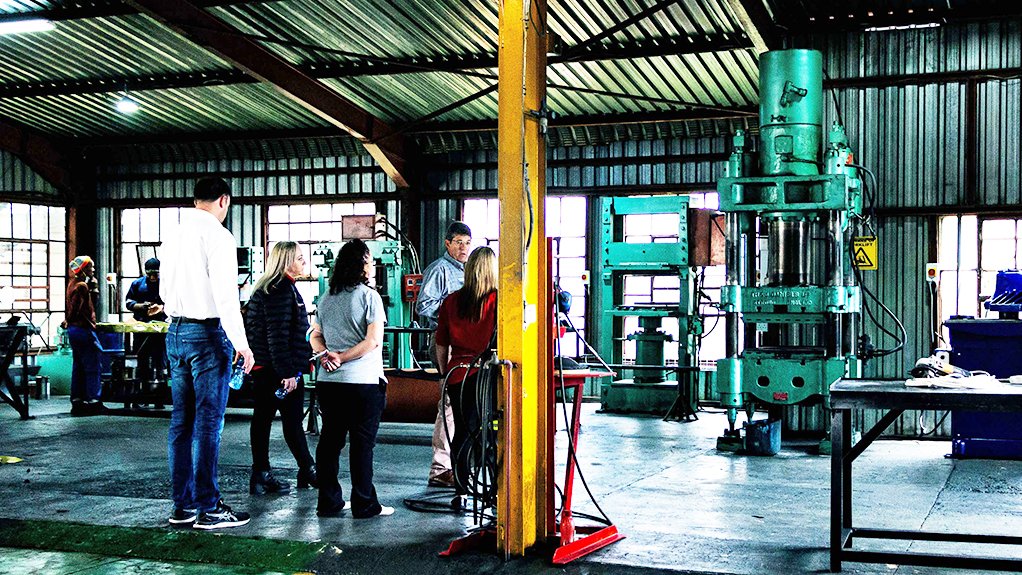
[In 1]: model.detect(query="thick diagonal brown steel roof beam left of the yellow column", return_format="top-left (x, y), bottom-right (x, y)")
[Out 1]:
top-left (127, 0), bottom-right (415, 188)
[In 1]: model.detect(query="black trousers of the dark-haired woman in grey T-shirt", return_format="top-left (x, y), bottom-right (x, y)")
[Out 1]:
top-left (316, 381), bottom-right (386, 517)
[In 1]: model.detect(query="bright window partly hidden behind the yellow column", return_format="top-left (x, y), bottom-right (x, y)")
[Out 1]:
top-left (462, 196), bottom-right (589, 355)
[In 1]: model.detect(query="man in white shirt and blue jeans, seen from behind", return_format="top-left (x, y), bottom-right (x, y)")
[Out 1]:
top-left (159, 178), bottom-right (254, 529)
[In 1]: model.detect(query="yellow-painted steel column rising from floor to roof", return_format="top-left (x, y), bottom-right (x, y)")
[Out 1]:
top-left (497, 0), bottom-right (552, 557)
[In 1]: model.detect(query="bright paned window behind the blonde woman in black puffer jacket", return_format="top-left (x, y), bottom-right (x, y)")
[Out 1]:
top-left (266, 201), bottom-right (376, 312)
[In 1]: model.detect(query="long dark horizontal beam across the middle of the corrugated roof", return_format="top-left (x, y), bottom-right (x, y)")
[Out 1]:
top-left (0, 34), bottom-right (752, 98)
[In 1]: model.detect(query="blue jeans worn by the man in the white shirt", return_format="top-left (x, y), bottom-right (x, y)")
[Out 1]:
top-left (167, 321), bottom-right (234, 512)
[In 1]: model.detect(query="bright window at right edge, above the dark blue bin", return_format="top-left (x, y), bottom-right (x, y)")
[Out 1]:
top-left (937, 215), bottom-right (1022, 335)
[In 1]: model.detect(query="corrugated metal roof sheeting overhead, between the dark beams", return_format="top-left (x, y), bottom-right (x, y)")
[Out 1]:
top-left (0, 0), bottom-right (756, 145)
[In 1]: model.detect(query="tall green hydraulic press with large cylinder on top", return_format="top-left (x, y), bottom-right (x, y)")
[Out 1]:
top-left (716, 50), bottom-right (863, 449)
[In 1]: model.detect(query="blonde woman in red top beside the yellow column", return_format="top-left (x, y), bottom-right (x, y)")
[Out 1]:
top-left (436, 247), bottom-right (497, 495)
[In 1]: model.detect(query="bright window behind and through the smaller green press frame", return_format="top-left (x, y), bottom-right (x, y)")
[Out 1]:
top-left (621, 192), bottom-right (726, 365)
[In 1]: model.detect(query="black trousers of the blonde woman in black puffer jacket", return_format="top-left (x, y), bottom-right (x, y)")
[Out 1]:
top-left (248, 368), bottom-right (316, 471)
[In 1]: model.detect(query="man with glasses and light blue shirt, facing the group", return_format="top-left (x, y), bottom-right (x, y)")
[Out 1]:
top-left (415, 222), bottom-right (472, 487)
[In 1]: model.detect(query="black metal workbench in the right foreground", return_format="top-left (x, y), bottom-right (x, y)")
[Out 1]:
top-left (830, 380), bottom-right (1022, 572)
